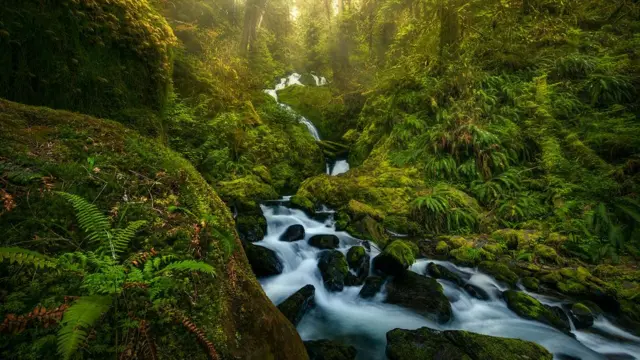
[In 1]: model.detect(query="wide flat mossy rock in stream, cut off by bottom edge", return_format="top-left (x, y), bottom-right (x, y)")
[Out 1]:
top-left (386, 327), bottom-right (553, 360)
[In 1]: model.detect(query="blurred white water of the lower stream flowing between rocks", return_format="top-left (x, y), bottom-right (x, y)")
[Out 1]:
top-left (256, 198), bottom-right (640, 360)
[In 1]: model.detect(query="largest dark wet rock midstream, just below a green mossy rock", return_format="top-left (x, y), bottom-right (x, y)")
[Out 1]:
top-left (385, 271), bottom-right (451, 323)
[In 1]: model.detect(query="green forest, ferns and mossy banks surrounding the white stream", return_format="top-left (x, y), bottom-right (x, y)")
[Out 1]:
top-left (0, 0), bottom-right (640, 359)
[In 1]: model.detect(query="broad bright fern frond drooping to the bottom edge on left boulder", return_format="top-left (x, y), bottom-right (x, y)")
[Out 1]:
top-left (58, 295), bottom-right (111, 360)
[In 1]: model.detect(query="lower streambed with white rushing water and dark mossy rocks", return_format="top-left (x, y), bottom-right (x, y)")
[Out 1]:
top-left (240, 198), bottom-right (640, 360)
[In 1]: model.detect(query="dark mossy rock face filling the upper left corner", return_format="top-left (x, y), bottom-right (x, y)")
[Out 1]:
top-left (0, 0), bottom-right (175, 134)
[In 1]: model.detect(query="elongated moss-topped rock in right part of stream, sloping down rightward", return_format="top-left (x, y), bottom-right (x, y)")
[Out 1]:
top-left (502, 290), bottom-right (571, 333)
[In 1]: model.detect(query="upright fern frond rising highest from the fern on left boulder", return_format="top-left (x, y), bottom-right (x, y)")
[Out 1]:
top-left (57, 192), bottom-right (111, 244)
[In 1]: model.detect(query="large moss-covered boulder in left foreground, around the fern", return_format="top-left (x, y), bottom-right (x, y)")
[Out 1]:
top-left (0, 100), bottom-right (307, 359)
